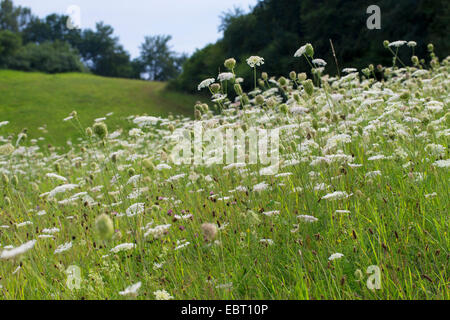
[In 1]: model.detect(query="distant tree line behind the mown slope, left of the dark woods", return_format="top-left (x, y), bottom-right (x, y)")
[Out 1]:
top-left (0, 0), bottom-right (187, 81)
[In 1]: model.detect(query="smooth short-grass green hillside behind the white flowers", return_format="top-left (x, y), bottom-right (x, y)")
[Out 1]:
top-left (0, 70), bottom-right (197, 145)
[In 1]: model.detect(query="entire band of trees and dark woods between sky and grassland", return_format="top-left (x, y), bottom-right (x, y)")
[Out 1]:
top-left (0, 0), bottom-right (450, 92)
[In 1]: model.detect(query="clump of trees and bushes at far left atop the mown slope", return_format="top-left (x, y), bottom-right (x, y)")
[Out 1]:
top-left (0, 0), bottom-right (146, 78)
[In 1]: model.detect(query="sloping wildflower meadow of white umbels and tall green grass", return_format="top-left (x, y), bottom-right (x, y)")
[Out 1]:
top-left (0, 41), bottom-right (450, 299)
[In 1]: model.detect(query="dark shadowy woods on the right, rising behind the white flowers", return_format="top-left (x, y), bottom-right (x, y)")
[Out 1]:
top-left (172, 0), bottom-right (450, 91)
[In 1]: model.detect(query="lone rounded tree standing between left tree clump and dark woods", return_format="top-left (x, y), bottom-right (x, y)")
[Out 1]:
top-left (139, 35), bottom-right (187, 81)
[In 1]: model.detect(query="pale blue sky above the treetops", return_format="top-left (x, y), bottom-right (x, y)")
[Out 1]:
top-left (13, 0), bottom-right (258, 58)
